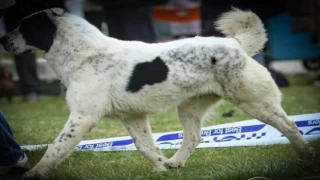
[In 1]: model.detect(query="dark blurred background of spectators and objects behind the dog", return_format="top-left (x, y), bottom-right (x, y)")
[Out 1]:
top-left (0, 0), bottom-right (320, 103)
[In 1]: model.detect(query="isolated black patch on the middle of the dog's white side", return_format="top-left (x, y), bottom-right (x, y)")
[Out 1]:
top-left (126, 57), bottom-right (169, 92)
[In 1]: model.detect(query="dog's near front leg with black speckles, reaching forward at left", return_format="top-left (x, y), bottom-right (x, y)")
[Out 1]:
top-left (25, 111), bottom-right (98, 178)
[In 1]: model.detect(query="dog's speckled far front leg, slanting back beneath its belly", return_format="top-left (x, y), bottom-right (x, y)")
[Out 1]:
top-left (122, 115), bottom-right (167, 171)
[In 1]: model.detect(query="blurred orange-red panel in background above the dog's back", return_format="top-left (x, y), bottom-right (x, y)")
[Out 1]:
top-left (153, 6), bottom-right (200, 23)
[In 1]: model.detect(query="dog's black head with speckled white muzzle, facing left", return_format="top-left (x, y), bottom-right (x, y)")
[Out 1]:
top-left (0, 8), bottom-right (64, 54)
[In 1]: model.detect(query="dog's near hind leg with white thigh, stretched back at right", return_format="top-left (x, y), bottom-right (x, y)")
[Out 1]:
top-left (215, 54), bottom-right (313, 156)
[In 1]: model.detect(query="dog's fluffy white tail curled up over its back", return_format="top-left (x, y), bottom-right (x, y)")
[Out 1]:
top-left (215, 8), bottom-right (267, 56)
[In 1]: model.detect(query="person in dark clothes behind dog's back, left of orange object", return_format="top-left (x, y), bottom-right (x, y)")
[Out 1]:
top-left (92, 0), bottom-right (166, 43)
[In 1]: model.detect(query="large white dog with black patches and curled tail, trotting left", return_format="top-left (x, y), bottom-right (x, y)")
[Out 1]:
top-left (0, 9), bottom-right (314, 177)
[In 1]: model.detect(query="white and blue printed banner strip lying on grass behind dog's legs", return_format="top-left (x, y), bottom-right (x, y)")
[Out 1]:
top-left (22, 113), bottom-right (320, 151)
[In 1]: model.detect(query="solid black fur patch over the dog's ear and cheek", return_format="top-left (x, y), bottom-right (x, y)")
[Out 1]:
top-left (20, 12), bottom-right (57, 52)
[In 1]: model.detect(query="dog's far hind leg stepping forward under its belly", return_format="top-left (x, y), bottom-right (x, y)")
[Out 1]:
top-left (165, 95), bottom-right (220, 168)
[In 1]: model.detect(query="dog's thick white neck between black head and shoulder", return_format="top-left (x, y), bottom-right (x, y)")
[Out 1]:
top-left (45, 16), bottom-right (117, 85)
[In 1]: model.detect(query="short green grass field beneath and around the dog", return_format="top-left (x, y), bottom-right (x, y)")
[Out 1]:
top-left (0, 75), bottom-right (320, 180)
